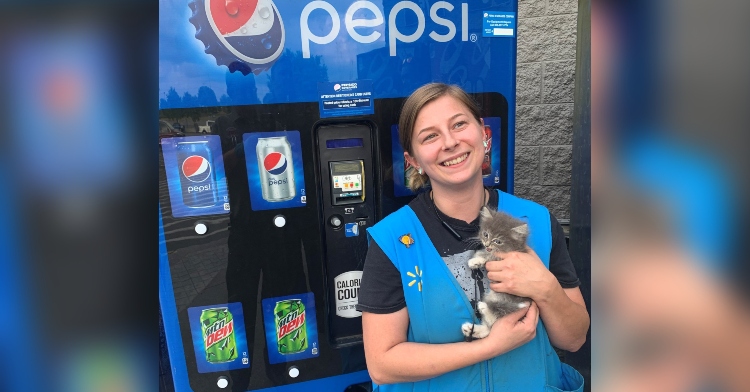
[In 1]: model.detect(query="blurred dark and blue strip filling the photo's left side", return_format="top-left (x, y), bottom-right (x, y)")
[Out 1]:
top-left (0, 1), bottom-right (158, 391)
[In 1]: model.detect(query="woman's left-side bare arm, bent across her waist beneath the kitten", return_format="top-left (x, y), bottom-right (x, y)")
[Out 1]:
top-left (362, 304), bottom-right (539, 384)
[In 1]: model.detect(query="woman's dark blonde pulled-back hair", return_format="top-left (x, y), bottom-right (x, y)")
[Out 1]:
top-left (398, 83), bottom-right (481, 192)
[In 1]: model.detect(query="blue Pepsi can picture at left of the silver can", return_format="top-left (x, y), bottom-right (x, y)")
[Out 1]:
top-left (177, 141), bottom-right (219, 208)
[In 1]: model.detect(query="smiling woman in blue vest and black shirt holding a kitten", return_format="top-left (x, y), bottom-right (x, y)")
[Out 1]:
top-left (358, 83), bottom-right (589, 391)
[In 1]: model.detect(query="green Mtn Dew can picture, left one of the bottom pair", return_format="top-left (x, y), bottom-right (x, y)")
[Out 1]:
top-left (200, 308), bottom-right (237, 363)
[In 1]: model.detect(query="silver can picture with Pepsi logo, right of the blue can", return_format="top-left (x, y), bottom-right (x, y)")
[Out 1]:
top-left (255, 136), bottom-right (296, 202)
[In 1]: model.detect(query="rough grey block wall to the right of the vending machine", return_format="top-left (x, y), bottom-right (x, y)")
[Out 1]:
top-left (514, 0), bottom-right (578, 219)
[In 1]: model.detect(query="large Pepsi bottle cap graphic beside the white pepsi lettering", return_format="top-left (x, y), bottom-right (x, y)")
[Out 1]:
top-left (188, 0), bottom-right (285, 75)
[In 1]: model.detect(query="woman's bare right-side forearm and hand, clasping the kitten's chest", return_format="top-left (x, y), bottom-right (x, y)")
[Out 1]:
top-left (485, 249), bottom-right (590, 351)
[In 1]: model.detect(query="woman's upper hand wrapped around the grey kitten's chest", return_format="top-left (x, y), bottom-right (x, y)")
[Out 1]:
top-left (485, 248), bottom-right (557, 301)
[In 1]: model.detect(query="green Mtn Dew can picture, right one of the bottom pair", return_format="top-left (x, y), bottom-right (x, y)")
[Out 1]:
top-left (273, 299), bottom-right (307, 354)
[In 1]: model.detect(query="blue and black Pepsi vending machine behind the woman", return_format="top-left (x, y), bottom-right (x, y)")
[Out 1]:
top-left (159, 0), bottom-right (517, 391)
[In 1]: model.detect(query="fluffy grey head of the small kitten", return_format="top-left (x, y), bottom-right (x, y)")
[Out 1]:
top-left (479, 207), bottom-right (529, 253)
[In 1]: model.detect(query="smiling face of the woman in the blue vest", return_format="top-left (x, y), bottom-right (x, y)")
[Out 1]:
top-left (404, 95), bottom-right (484, 192)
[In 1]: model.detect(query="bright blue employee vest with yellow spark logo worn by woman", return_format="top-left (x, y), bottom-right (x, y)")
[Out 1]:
top-left (367, 191), bottom-right (583, 392)
